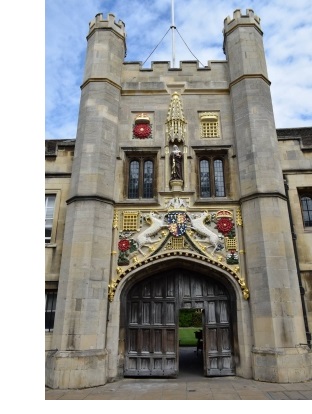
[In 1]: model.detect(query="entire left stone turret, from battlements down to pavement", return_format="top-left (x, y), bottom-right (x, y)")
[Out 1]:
top-left (46, 14), bottom-right (126, 388)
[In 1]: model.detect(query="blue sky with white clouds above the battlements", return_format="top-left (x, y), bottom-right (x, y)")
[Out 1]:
top-left (45, 0), bottom-right (312, 139)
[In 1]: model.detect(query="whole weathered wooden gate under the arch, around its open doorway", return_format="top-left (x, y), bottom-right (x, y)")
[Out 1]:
top-left (124, 269), bottom-right (235, 376)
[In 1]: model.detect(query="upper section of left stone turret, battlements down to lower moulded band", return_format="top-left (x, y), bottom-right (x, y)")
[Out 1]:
top-left (71, 14), bottom-right (126, 201)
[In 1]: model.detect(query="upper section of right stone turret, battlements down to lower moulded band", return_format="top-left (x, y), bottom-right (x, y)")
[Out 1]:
top-left (224, 9), bottom-right (284, 197)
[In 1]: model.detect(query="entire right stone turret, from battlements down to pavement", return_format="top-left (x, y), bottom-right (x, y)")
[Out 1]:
top-left (224, 10), bottom-right (311, 382)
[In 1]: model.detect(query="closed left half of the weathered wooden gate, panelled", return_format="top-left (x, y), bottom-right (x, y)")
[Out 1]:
top-left (124, 275), bottom-right (178, 377)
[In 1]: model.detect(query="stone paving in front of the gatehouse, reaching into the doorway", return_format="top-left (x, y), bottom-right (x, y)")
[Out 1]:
top-left (45, 349), bottom-right (312, 400)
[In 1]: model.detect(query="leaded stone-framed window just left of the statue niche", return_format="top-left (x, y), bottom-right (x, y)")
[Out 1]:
top-left (127, 156), bottom-right (155, 199)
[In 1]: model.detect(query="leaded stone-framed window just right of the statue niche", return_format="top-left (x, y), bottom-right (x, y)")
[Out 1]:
top-left (199, 155), bottom-right (226, 198)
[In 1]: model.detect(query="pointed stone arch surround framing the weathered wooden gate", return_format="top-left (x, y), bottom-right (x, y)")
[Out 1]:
top-left (107, 254), bottom-right (252, 378)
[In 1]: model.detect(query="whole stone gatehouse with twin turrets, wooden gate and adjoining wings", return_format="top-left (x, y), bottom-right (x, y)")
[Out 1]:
top-left (45, 9), bottom-right (312, 388)
